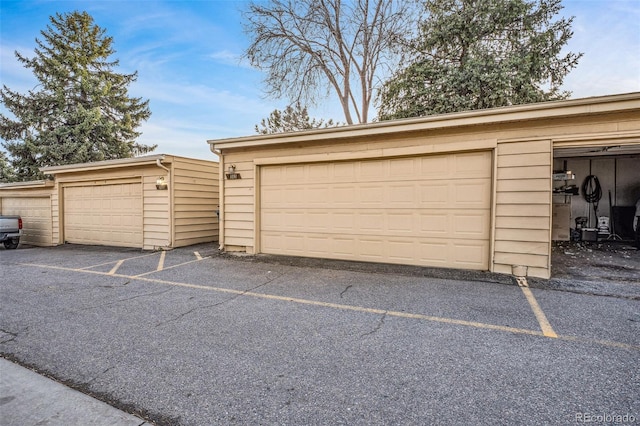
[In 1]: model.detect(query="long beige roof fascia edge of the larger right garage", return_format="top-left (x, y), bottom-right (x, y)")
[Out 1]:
top-left (207, 92), bottom-right (640, 152)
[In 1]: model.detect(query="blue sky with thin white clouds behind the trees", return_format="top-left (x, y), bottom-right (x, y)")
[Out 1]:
top-left (0, 0), bottom-right (640, 159)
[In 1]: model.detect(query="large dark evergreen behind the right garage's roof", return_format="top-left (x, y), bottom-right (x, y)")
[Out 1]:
top-left (379, 0), bottom-right (582, 120)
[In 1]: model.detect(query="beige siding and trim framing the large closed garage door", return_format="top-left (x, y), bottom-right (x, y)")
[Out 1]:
top-left (219, 96), bottom-right (640, 278)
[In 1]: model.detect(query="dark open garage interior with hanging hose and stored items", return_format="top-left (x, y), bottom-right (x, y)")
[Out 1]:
top-left (552, 144), bottom-right (640, 286)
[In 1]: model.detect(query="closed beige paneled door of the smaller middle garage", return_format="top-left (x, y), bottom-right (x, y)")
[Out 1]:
top-left (64, 182), bottom-right (142, 247)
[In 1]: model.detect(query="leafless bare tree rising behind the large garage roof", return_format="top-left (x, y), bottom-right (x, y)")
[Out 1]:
top-left (244, 0), bottom-right (413, 124)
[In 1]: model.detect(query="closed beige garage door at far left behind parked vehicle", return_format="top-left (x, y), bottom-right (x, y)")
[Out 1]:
top-left (2, 197), bottom-right (53, 246)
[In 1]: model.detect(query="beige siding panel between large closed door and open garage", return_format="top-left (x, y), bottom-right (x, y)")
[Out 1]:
top-left (493, 140), bottom-right (552, 278)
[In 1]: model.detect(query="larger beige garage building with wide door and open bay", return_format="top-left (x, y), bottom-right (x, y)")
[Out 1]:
top-left (208, 93), bottom-right (640, 278)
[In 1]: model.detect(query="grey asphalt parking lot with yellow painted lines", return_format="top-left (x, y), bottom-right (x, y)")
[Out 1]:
top-left (0, 245), bottom-right (640, 425)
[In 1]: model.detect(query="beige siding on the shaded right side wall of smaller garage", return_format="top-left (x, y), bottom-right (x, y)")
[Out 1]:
top-left (172, 157), bottom-right (220, 247)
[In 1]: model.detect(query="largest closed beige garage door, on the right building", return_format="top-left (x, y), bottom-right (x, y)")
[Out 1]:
top-left (260, 152), bottom-right (492, 270)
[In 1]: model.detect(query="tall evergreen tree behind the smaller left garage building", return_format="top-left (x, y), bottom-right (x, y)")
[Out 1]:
top-left (0, 12), bottom-right (155, 180)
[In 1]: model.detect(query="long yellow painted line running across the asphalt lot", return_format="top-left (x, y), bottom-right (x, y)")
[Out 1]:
top-left (22, 260), bottom-right (640, 351)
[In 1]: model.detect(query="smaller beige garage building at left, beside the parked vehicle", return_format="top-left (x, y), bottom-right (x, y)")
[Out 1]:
top-left (0, 155), bottom-right (219, 250)
